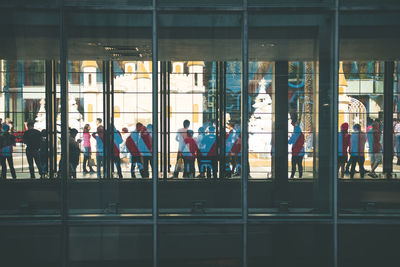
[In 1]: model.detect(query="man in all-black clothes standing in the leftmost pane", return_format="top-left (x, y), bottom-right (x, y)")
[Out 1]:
top-left (23, 121), bottom-right (43, 179)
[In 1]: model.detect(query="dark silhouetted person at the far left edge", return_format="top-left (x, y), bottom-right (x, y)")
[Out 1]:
top-left (0, 124), bottom-right (17, 179)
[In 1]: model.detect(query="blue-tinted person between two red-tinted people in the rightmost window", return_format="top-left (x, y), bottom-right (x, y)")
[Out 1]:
top-left (350, 124), bottom-right (367, 179)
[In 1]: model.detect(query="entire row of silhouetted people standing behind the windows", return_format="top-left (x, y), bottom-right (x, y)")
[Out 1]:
top-left (0, 118), bottom-right (390, 179)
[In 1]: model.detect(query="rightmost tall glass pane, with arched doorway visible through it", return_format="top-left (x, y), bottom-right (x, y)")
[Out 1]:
top-left (337, 12), bottom-right (400, 216)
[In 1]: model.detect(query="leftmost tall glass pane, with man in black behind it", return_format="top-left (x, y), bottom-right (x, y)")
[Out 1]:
top-left (0, 9), bottom-right (60, 216)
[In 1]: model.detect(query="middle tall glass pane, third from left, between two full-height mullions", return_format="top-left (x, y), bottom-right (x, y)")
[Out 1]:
top-left (159, 13), bottom-right (242, 218)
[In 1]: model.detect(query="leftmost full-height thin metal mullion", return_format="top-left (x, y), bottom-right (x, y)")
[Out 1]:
top-left (60, 1), bottom-right (69, 267)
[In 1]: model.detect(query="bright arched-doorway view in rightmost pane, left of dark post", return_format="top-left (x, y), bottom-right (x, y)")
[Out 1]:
top-left (338, 61), bottom-right (384, 179)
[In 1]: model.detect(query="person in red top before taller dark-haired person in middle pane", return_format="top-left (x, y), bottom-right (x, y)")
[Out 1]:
top-left (182, 130), bottom-right (200, 178)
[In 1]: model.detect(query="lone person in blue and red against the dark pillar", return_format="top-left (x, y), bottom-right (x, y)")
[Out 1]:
top-left (288, 125), bottom-right (304, 178)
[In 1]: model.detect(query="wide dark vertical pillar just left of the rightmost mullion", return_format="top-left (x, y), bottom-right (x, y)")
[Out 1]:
top-left (314, 14), bottom-right (339, 213)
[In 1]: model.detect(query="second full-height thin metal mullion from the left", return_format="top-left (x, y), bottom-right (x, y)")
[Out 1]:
top-left (151, 0), bottom-right (158, 267)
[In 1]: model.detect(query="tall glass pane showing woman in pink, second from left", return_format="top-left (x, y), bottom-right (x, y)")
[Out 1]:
top-left (67, 11), bottom-right (152, 216)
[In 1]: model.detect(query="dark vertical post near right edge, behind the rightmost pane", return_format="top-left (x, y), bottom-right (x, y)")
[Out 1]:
top-left (383, 61), bottom-right (394, 179)
